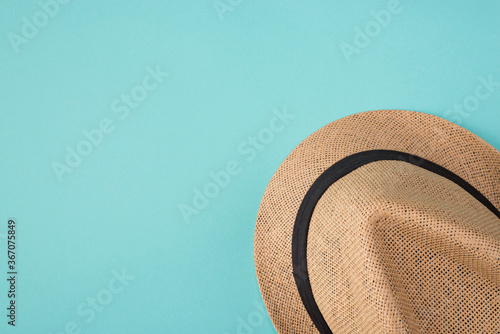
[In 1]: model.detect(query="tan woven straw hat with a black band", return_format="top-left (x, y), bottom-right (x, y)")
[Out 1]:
top-left (255, 110), bottom-right (500, 334)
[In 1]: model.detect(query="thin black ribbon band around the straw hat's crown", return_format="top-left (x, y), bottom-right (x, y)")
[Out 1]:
top-left (292, 150), bottom-right (500, 334)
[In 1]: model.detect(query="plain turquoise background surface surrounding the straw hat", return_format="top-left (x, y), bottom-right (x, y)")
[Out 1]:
top-left (0, 0), bottom-right (500, 334)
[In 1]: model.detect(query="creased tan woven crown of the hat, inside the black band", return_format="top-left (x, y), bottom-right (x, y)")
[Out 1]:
top-left (307, 161), bottom-right (500, 333)
